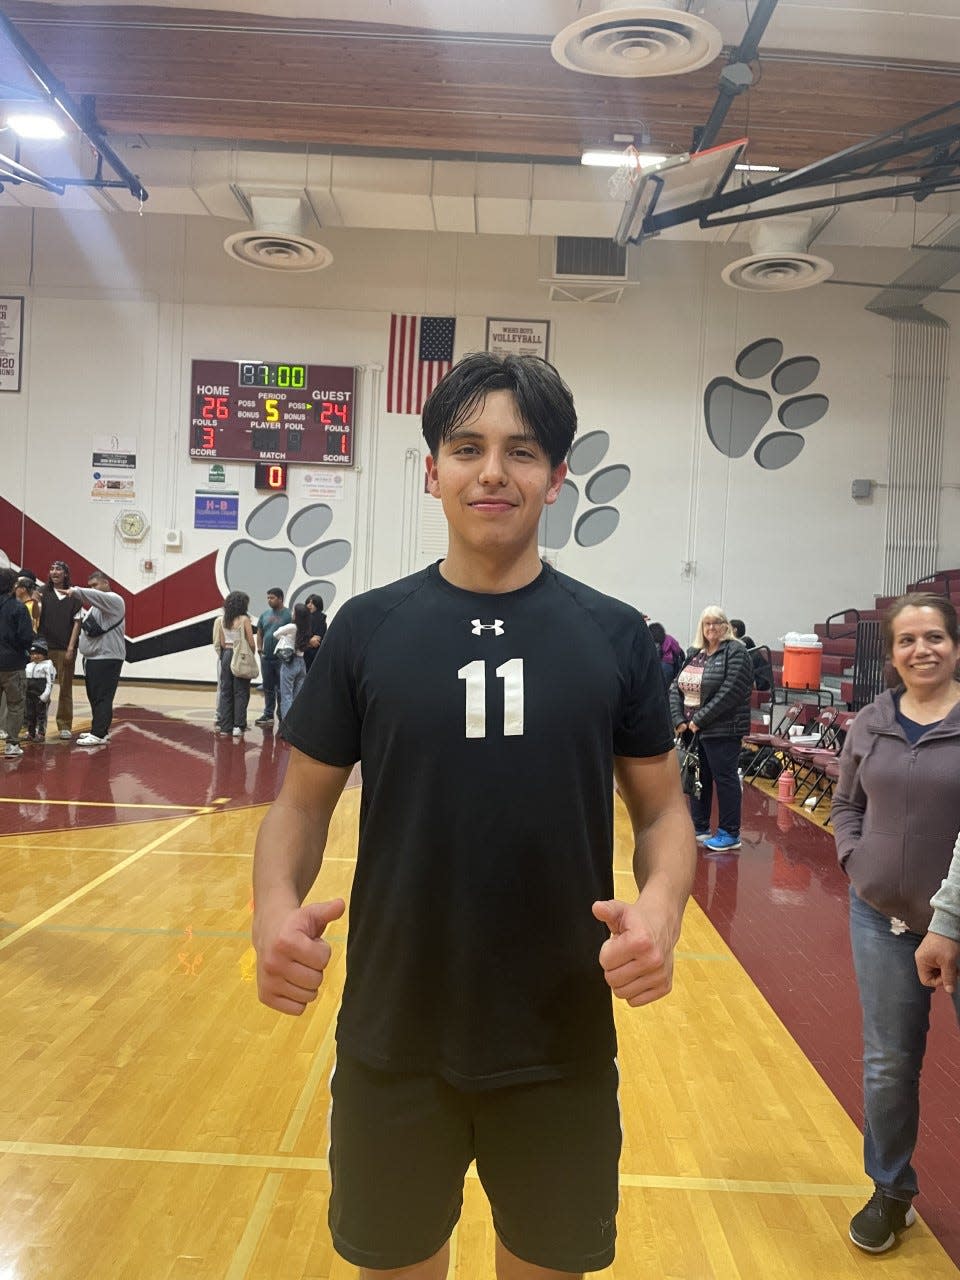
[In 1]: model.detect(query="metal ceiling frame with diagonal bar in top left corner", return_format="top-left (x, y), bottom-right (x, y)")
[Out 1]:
top-left (0, 13), bottom-right (148, 204)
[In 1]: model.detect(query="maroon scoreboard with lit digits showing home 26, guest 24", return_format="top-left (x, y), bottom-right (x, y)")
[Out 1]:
top-left (189, 360), bottom-right (356, 467)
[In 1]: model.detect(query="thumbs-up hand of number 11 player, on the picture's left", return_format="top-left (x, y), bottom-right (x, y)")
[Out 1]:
top-left (257, 897), bottom-right (347, 1016)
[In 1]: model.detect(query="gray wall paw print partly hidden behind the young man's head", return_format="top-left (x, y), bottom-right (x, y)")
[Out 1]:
top-left (538, 431), bottom-right (630, 550)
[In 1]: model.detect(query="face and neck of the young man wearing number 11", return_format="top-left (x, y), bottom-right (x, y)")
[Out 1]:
top-left (426, 390), bottom-right (567, 566)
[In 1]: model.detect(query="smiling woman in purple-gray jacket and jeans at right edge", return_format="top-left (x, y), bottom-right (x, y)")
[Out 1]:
top-left (832, 593), bottom-right (960, 1253)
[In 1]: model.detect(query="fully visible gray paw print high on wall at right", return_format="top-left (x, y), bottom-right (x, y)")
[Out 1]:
top-left (703, 338), bottom-right (829, 471)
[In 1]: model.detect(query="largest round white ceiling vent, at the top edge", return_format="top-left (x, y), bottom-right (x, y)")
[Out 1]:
top-left (550, 0), bottom-right (723, 79)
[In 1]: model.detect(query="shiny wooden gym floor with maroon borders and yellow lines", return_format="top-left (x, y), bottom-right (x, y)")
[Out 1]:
top-left (0, 686), bottom-right (960, 1280)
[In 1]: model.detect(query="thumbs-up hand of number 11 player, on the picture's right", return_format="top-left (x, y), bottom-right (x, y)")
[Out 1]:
top-left (593, 899), bottom-right (673, 1007)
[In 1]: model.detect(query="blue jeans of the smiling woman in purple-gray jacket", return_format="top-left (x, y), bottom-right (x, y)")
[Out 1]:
top-left (850, 886), bottom-right (960, 1201)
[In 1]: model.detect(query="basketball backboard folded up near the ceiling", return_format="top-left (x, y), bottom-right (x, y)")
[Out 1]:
top-left (611, 138), bottom-right (749, 244)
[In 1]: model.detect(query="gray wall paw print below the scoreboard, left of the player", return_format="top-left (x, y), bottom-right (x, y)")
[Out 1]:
top-left (223, 493), bottom-right (353, 613)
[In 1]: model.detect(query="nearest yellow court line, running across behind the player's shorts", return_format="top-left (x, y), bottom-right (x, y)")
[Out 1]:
top-left (0, 1139), bottom-right (869, 1212)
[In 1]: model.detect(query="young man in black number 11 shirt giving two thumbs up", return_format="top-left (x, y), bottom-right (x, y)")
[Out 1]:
top-left (253, 355), bottom-right (696, 1280)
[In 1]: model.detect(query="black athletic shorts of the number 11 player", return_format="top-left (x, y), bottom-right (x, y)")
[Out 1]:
top-left (329, 1053), bottom-right (622, 1272)
